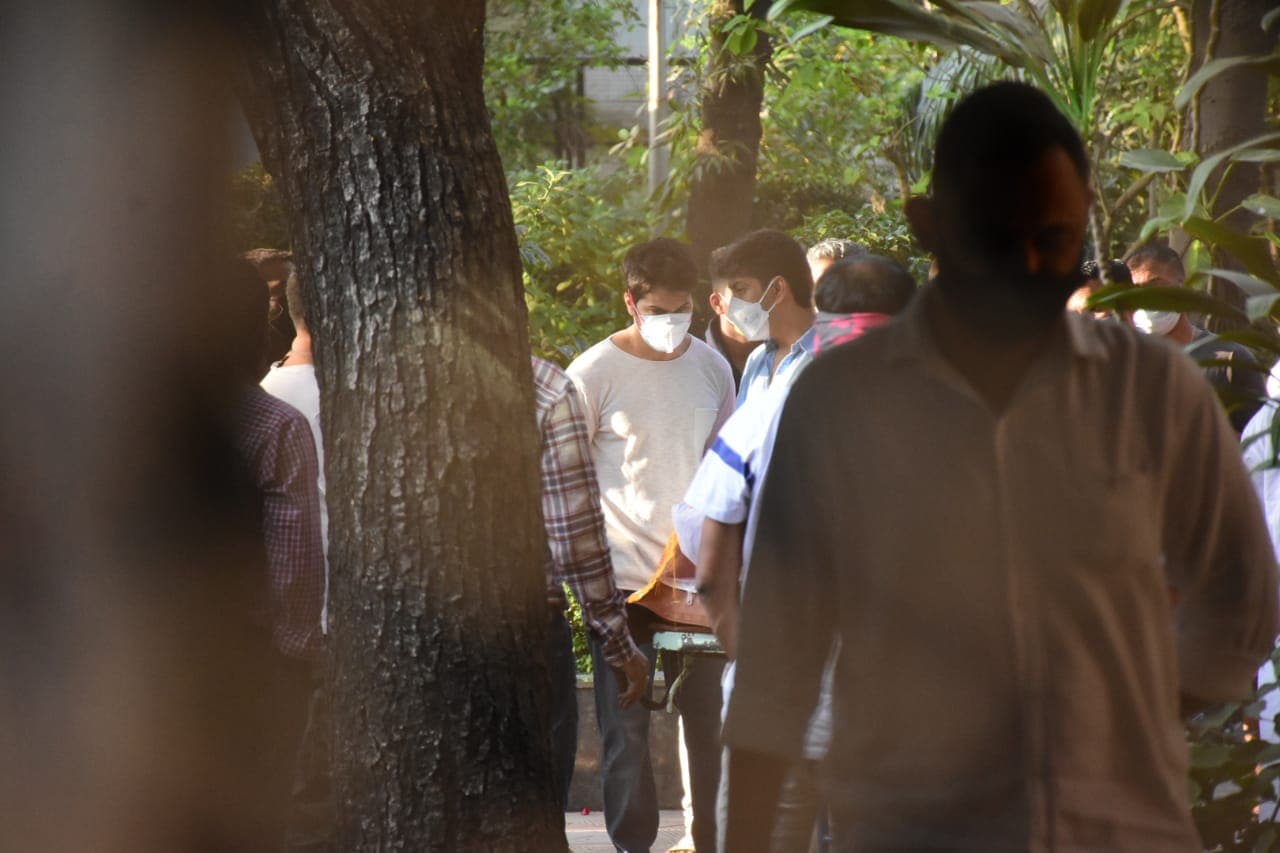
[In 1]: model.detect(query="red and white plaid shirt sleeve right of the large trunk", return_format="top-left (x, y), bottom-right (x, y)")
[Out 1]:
top-left (534, 361), bottom-right (639, 666)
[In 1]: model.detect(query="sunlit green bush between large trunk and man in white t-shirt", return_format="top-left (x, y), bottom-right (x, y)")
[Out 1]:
top-left (508, 164), bottom-right (653, 364)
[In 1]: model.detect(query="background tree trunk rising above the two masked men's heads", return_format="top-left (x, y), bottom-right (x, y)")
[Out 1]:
top-left (687, 0), bottom-right (772, 272)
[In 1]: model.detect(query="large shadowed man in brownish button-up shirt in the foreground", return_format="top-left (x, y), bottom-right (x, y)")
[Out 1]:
top-left (724, 83), bottom-right (1277, 853)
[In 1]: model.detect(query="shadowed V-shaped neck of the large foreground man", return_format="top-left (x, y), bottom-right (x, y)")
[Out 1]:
top-left (922, 287), bottom-right (1066, 416)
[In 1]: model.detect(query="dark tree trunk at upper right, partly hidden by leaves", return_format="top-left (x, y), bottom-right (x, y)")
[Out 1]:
top-left (1190, 0), bottom-right (1275, 328)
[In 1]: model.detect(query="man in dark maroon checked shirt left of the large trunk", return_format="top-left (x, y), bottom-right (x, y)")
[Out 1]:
top-left (225, 261), bottom-right (325, 847)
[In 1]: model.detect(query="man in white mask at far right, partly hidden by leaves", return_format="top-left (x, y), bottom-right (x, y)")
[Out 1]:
top-left (1125, 243), bottom-right (1267, 433)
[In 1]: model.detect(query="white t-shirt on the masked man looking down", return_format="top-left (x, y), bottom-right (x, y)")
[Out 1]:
top-left (567, 338), bottom-right (733, 590)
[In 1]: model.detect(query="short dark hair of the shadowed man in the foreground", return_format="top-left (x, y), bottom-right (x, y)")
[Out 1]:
top-left (932, 81), bottom-right (1089, 209)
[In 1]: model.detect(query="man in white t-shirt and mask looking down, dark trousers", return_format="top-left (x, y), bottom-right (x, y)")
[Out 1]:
top-left (568, 238), bottom-right (733, 850)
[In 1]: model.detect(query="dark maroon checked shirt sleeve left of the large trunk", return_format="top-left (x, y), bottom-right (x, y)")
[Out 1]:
top-left (241, 392), bottom-right (325, 658)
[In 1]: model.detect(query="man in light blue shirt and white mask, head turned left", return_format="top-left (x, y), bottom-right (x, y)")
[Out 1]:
top-left (710, 228), bottom-right (814, 406)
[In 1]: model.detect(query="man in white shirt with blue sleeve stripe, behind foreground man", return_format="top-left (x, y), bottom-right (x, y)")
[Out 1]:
top-left (677, 254), bottom-right (915, 852)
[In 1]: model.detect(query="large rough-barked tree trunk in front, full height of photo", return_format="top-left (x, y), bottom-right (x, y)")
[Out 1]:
top-left (242, 0), bottom-right (563, 852)
